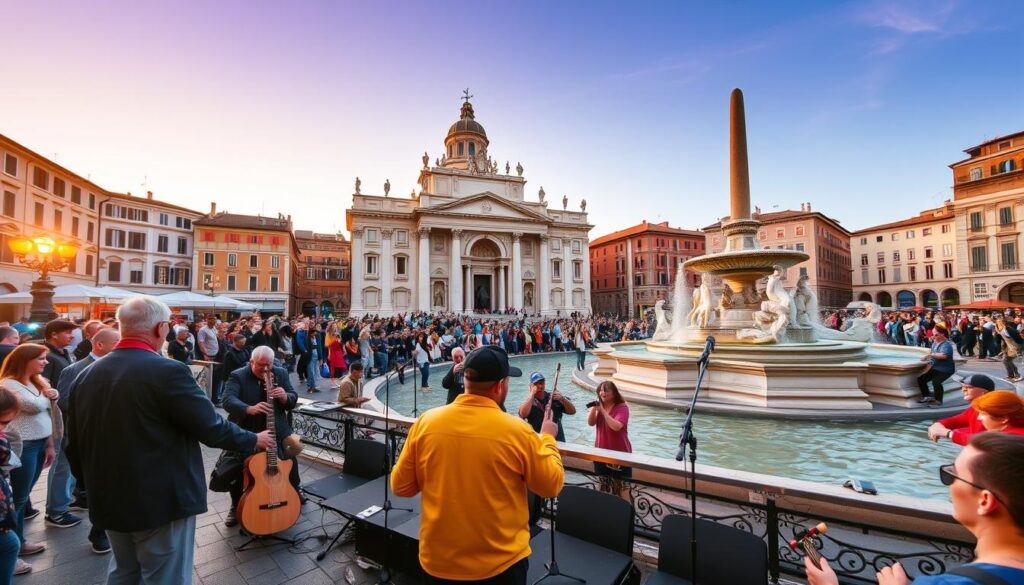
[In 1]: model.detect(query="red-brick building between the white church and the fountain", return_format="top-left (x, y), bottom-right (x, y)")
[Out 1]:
top-left (590, 220), bottom-right (705, 316)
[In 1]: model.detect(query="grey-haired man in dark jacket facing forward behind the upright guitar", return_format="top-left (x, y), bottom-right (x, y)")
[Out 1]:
top-left (224, 345), bottom-right (299, 527)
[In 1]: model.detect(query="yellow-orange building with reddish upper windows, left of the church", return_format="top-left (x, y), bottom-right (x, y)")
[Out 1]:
top-left (191, 204), bottom-right (299, 316)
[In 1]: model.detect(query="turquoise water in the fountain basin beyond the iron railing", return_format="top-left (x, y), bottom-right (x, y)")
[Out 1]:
top-left (378, 354), bottom-right (959, 500)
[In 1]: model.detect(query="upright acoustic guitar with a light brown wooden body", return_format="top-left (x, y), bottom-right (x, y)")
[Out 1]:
top-left (237, 372), bottom-right (302, 536)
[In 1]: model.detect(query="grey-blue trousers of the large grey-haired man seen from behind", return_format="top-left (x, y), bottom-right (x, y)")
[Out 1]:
top-left (106, 516), bottom-right (196, 585)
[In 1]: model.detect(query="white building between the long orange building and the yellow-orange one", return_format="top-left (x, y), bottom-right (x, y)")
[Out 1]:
top-left (97, 192), bottom-right (203, 294)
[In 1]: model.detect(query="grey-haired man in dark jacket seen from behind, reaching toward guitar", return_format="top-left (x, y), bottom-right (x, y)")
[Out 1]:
top-left (68, 296), bottom-right (270, 583)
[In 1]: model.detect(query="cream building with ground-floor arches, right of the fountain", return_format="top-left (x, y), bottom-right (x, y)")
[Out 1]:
top-left (850, 202), bottom-right (961, 308)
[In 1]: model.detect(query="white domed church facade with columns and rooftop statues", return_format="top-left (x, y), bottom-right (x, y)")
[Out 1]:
top-left (345, 94), bottom-right (592, 316)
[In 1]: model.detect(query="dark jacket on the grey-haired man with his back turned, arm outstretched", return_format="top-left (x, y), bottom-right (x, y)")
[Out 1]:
top-left (68, 348), bottom-right (256, 532)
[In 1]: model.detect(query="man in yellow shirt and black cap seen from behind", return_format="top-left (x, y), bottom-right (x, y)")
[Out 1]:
top-left (391, 345), bottom-right (565, 585)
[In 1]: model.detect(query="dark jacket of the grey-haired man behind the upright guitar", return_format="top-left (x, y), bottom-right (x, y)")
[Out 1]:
top-left (224, 365), bottom-right (299, 457)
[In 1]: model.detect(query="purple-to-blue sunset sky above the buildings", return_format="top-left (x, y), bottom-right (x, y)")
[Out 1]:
top-left (0, 0), bottom-right (1024, 238)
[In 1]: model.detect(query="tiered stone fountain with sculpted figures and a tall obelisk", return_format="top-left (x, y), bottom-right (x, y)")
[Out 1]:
top-left (577, 89), bottom-right (956, 416)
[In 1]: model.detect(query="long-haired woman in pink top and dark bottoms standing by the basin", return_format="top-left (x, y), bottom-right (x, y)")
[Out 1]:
top-left (587, 380), bottom-right (633, 499)
